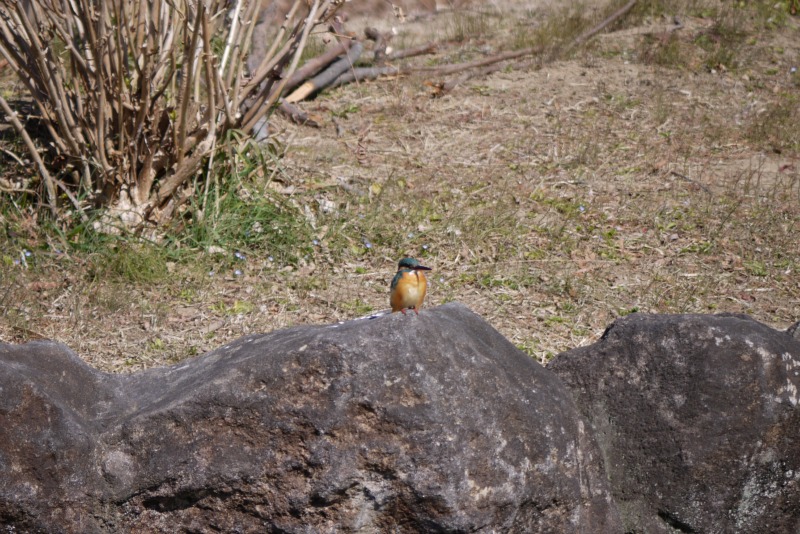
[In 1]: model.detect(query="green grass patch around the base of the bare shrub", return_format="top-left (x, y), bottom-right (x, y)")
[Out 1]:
top-left (0, 127), bottom-right (312, 285)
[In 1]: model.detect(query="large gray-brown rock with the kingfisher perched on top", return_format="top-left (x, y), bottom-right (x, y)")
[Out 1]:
top-left (0, 304), bottom-right (621, 533)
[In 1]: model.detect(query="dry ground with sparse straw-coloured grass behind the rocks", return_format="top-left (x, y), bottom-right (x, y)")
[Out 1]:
top-left (0, 0), bottom-right (800, 372)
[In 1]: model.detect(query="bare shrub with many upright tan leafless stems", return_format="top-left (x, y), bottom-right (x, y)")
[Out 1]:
top-left (0, 0), bottom-right (342, 228)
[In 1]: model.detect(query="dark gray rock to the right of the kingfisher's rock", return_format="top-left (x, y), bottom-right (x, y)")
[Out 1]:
top-left (548, 314), bottom-right (800, 533)
